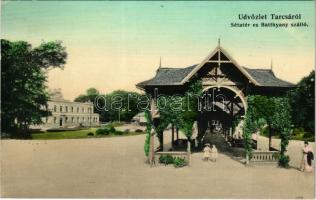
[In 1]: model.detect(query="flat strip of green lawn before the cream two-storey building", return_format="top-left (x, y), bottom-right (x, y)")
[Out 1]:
top-left (32, 128), bottom-right (145, 140)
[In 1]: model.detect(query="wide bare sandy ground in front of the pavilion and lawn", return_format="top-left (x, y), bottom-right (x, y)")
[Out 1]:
top-left (1, 135), bottom-right (314, 198)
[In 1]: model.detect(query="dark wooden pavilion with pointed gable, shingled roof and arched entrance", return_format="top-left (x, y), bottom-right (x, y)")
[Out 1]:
top-left (136, 42), bottom-right (294, 162)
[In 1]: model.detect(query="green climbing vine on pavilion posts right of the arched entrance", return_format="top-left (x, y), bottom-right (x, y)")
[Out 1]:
top-left (243, 95), bottom-right (291, 167)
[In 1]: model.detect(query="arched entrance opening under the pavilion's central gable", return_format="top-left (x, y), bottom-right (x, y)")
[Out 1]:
top-left (197, 86), bottom-right (247, 150)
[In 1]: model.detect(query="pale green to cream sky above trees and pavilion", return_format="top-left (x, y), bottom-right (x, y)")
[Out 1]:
top-left (1, 1), bottom-right (315, 100)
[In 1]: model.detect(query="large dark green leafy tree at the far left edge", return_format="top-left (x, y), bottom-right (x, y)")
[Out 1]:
top-left (1, 39), bottom-right (67, 137)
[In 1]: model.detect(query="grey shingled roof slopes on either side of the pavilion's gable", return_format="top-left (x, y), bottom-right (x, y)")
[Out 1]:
top-left (137, 65), bottom-right (294, 88)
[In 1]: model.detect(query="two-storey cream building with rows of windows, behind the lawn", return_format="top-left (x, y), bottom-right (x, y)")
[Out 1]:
top-left (40, 100), bottom-right (99, 129)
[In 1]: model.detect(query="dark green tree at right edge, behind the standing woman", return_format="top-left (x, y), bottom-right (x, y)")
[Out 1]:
top-left (288, 70), bottom-right (315, 132)
